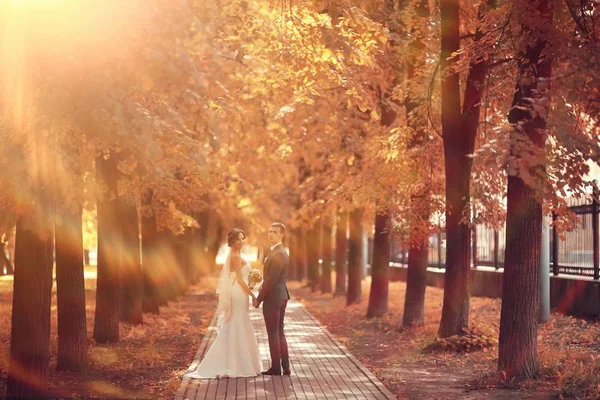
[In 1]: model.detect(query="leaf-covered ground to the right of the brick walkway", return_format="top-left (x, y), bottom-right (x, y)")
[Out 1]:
top-left (289, 278), bottom-right (600, 399)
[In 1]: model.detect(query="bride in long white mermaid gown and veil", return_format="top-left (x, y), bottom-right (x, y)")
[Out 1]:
top-left (185, 229), bottom-right (261, 379)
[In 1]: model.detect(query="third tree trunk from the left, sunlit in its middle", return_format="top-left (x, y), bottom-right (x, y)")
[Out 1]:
top-left (94, 156), bottom-right (122, 343)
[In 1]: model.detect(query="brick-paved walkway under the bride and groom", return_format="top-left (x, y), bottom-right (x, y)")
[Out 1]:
top-left (175, 301), bottom-right (395, 400)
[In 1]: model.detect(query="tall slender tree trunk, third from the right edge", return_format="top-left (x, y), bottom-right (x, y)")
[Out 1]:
top-left (402, 0), bottom-right (431, 327)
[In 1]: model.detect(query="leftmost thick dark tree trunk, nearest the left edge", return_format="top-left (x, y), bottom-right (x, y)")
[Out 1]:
top-left (6, 214), bottom-right (53, 398)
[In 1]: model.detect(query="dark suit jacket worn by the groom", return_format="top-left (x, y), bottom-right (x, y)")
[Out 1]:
top-left (257, 244), bottom-right (290, 303)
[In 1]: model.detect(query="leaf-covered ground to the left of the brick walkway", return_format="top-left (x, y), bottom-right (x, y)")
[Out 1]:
top-left (0, 268), bottom-right (217, 399)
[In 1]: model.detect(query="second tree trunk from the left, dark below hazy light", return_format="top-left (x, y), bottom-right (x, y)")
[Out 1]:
top-left (55, 206), bottom-right (87, 371)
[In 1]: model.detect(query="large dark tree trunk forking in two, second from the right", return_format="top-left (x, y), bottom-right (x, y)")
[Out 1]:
top-left (439, 0), bottom-right (496, 337)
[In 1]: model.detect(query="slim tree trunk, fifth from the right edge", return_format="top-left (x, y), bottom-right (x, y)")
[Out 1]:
top-left (346, 208), bottom-right (365, 305)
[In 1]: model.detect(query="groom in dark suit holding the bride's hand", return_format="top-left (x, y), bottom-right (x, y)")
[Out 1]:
top-left (253, 222), bottom-right (290, 375)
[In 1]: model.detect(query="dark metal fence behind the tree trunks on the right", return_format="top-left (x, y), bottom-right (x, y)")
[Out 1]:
top-left (392, 192), bottom-right (600, 280)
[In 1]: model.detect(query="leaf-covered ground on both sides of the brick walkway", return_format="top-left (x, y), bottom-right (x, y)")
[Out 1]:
top-left (0, 268), bottom-right (600, 399)
